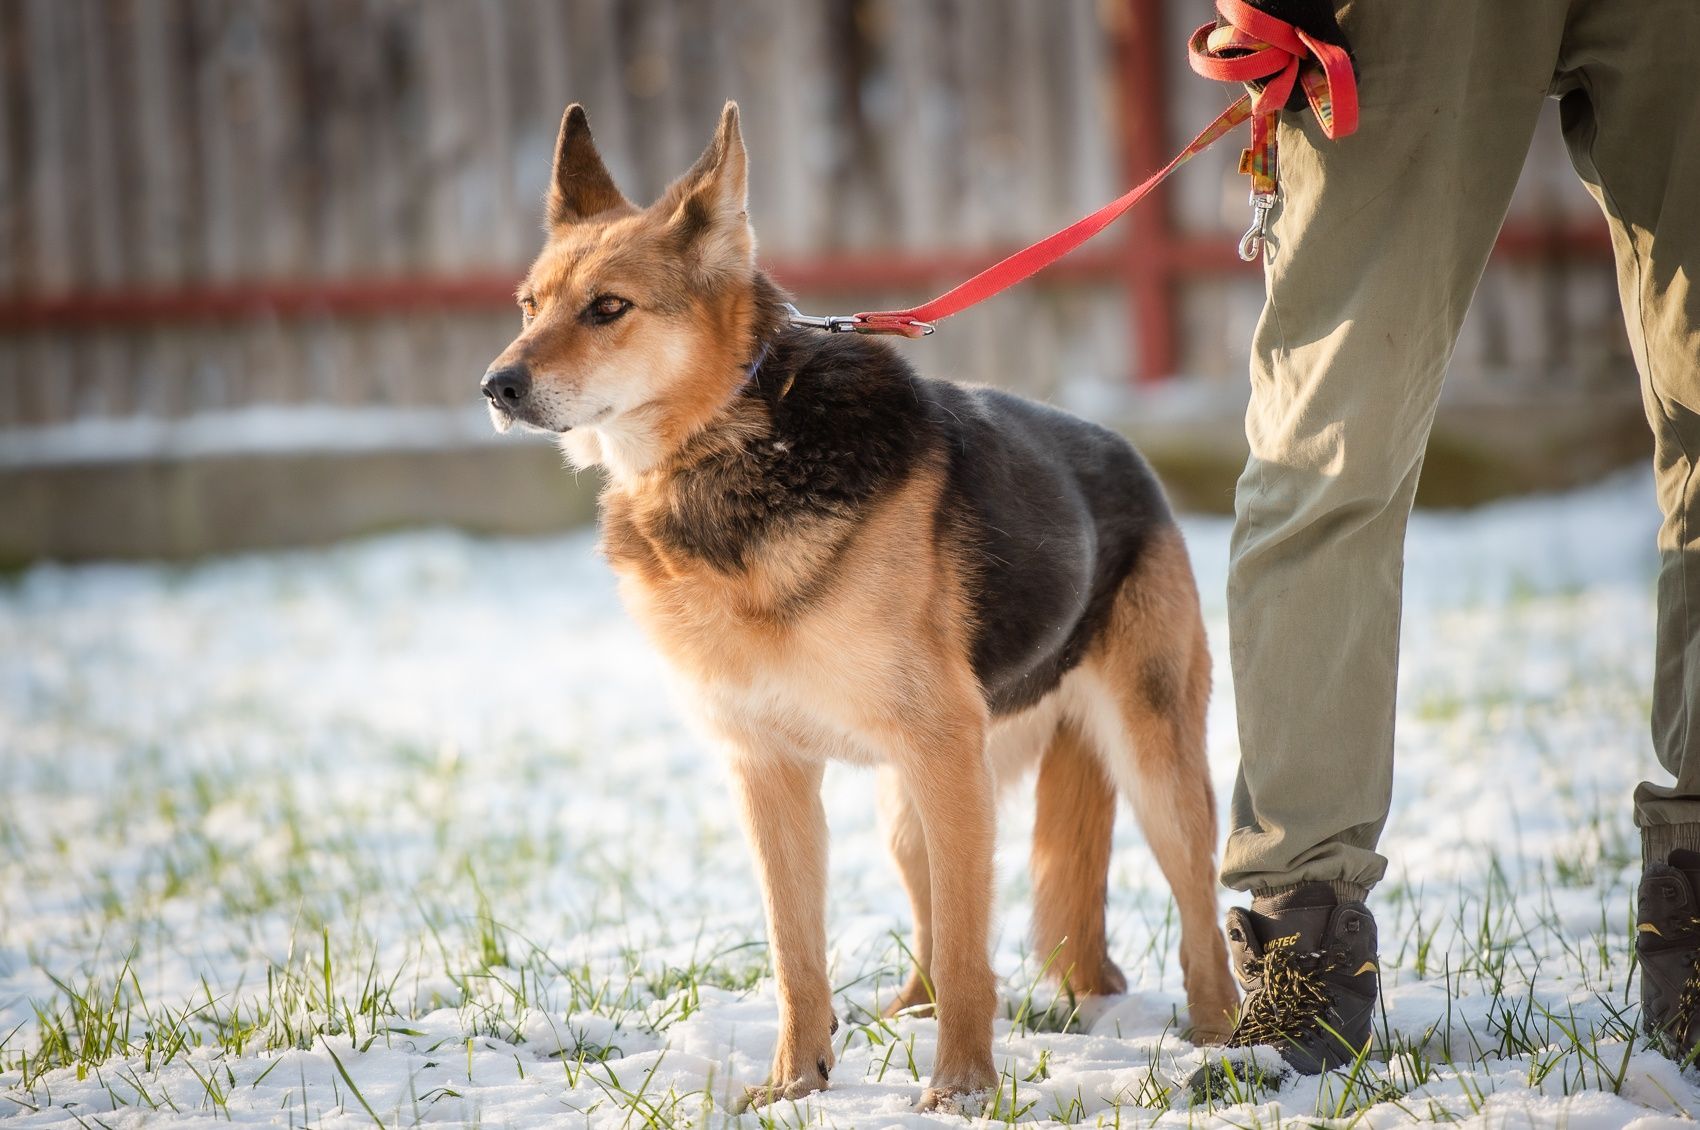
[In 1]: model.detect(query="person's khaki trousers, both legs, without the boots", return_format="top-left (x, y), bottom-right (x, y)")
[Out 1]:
top-left (1222, 0), bottom-right (1700, 894)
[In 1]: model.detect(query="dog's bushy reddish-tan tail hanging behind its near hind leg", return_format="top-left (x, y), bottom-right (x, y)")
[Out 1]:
top-left (1032, 720), bottom-right (1127, 994)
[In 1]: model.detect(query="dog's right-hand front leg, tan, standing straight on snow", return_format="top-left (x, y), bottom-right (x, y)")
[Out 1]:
top-left (901, 717), bottom-right (998, 1110)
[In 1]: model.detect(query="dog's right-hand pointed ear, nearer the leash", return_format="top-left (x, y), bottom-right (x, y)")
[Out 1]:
top-left (656, 102), bottom-right (755, 270)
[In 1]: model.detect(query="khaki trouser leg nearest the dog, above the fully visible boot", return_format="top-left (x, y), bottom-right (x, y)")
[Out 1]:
top-left (1222, 0), bottom-right (1566, 899)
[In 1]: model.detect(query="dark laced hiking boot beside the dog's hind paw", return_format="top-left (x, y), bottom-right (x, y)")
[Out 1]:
top-left (1227, 884), bottom-right (1380, 1076)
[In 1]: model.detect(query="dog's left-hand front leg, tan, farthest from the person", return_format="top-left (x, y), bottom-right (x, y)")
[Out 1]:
top-left (731, 754), bottom-right (838, 1106)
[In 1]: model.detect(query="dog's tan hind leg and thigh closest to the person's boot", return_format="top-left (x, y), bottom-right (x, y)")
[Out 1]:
top-left (1083, 527), bottom-right (1238, 1043)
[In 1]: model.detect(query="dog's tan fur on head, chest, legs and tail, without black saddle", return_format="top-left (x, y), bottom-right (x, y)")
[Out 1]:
top-left (493, 105), bottom-right (1234, 1106)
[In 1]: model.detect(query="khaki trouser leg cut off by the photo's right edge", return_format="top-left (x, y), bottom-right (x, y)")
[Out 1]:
top-left (1561, 0), bottom-right (1700, 862)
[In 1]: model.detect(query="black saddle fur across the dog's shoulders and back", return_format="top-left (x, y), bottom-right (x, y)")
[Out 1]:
top-left (666, 328), bottom-right (1173, 715)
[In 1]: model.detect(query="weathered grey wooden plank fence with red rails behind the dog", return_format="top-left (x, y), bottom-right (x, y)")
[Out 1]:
top-left (0, 0), bottom-right (1632, 556)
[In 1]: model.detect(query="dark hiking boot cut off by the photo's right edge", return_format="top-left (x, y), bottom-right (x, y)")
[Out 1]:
top-left (1635, 848), bottom-right (1700, 1064)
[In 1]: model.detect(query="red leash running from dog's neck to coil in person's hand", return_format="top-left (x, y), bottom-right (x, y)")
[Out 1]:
top-left (791, 0), bottom-right (1358, 338)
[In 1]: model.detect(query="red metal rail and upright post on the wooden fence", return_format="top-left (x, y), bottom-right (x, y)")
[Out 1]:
top-left (0, 0), bottom-right (1612, 382)
